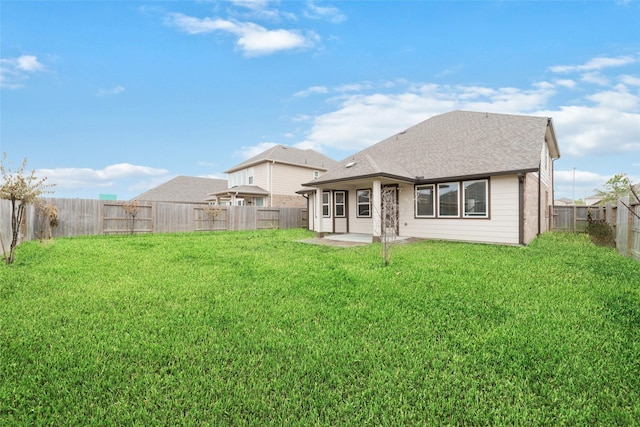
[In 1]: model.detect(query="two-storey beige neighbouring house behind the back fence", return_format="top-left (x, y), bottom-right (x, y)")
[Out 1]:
top-left (207, 145), bottom-right (338, 207)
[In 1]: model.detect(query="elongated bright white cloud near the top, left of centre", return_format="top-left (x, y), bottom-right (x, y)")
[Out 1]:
top-left (166, 13), bottom-right (319, 56)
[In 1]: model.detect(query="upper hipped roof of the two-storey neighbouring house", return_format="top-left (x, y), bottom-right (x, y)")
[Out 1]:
top-left (224, 145), bottom-right (338, 173)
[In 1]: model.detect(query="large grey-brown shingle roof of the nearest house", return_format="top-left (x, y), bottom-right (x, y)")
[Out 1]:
top-left (303, 111), bottom-right (560, 186)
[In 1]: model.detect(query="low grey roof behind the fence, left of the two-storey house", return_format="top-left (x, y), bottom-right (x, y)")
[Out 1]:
top-left (132, 176), bottom-right (228, 203)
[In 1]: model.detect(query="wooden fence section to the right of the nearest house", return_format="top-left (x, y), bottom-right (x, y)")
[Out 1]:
top-left (550, 198), bottom-right (640, 261)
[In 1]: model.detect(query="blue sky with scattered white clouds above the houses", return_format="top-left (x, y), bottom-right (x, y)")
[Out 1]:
top-left (0, 0), bottom-right (640, 199)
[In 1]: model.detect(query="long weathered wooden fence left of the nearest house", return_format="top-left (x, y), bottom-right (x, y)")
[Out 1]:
top-left (0, 198), bottom-right (308, 248)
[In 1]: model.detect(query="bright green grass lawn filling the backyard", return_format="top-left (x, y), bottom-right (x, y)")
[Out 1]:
top-left (0, 230), bottom-right (640, 426)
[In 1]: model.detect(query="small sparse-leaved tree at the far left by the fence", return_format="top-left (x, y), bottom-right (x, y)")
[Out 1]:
top-left (0, 153), bottom-right (51, 264)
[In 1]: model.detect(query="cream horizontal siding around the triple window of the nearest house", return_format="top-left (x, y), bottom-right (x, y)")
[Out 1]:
top-left (399, 175), bottom-right (519, 244)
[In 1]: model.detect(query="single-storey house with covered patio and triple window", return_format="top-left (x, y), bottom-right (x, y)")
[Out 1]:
top-left (301, 111), bottom-right (560, 244)
